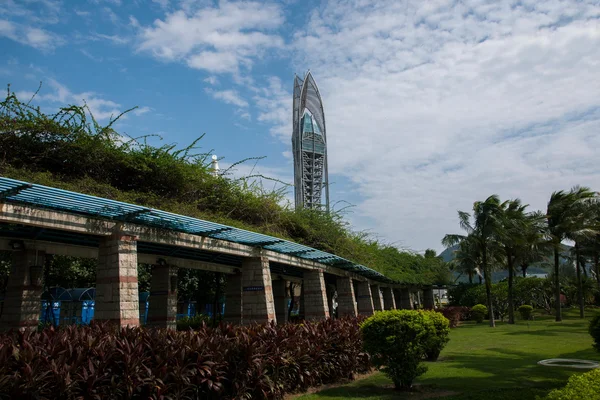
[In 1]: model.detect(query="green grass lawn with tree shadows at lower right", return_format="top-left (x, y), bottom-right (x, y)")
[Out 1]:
top-left (299, 310), bottom-right (600, 400)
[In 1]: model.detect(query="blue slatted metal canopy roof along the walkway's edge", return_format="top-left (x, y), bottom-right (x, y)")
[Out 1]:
top-left (0, 177), bottom-right (398, 283)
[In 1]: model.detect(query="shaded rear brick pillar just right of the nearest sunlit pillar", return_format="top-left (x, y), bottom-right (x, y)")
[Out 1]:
top-left (148, 264), bottom-right (177, 329)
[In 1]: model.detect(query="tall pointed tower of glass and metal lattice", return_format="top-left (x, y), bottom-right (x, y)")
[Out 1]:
top-left (292, 71), bottom-right (329, 211)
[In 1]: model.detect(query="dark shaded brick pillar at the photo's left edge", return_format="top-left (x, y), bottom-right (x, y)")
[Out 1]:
top-left (0, 250), bottom-right (45, 330)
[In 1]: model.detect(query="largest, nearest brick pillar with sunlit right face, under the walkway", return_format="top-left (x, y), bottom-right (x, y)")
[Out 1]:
top-left (94, 234), bottom-right (140, 326)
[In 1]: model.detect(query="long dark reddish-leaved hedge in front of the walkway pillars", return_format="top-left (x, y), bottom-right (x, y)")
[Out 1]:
top-left (0, 318), bottom-right (370, 399)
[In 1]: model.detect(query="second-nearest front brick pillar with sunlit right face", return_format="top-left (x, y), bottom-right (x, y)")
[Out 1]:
top-left (242, 257), bottom-right (276, 324)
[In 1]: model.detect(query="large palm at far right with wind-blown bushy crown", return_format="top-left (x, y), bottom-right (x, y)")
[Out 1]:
top-left (546, 186), bottom-right (596, 321)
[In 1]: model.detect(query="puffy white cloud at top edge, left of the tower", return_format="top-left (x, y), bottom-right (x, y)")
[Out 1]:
top-left (133, 1), bottom-right (283, 73)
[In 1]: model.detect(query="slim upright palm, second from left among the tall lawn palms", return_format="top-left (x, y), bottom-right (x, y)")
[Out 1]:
top-left (497, 199), bottom-right (527, 324)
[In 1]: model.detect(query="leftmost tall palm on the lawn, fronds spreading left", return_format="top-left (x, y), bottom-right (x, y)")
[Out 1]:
top-left (442, 194), bottom-right (501, 327)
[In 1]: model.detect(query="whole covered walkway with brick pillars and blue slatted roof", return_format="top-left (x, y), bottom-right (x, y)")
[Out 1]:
top-left (0, 177), bottom-right (433, 328)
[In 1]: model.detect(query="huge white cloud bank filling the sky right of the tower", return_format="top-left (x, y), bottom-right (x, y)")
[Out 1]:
top-left (284, 0), bottom-right (600, 250)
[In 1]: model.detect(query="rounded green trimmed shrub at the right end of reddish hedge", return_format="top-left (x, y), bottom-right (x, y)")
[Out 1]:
top-left (360, 310), bottom-right (436, 390)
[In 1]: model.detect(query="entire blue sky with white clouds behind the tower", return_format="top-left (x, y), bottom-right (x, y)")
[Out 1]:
top-left (0, 0), bottom-right (600, 251)
